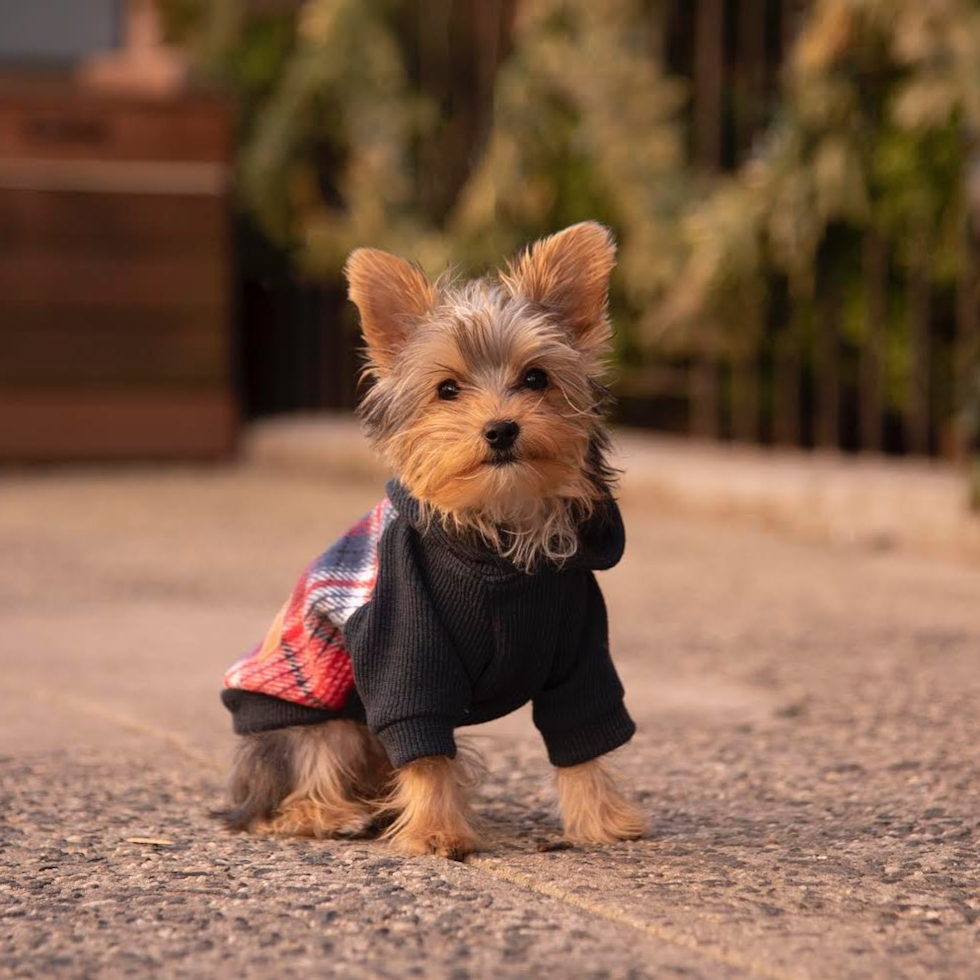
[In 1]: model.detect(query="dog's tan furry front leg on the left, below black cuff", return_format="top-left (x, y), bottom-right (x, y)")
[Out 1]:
top-left (385, 756), bottom-right (480, 861)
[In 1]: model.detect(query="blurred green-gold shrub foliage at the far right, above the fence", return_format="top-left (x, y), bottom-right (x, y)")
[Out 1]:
top-left (671, 0), bottom-right (980, 339)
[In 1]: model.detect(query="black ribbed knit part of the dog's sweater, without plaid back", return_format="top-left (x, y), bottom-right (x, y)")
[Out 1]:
top-left (224, 481), bottom-right (635, 766)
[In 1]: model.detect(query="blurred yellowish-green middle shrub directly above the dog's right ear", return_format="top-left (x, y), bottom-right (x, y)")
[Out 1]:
top-left (452, 0), bottom-right (689, 322)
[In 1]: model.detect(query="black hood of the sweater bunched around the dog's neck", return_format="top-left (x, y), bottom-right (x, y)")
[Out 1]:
top-left (385, 479), bottom-right (626, 578)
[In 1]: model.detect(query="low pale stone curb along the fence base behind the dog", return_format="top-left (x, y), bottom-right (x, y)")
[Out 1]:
top-left (242, 413), bottom-right (980, 566)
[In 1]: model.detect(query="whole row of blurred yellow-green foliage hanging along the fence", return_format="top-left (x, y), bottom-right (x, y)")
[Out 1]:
top-left (162, 0), bottom-right (980, 440)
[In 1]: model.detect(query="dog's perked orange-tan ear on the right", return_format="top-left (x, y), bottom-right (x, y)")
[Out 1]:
top-left (501, 221), bottom-right (616, 345)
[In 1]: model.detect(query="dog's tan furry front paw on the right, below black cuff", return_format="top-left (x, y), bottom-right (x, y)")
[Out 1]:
top-left (555, 759), bottom-right (647, 844)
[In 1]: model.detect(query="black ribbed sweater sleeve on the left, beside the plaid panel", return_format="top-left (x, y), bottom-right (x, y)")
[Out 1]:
top-left (344, 519), bottom-right (472, 767)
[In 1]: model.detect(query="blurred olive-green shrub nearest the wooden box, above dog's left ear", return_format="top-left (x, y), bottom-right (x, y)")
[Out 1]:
top-left (165, 0), bottom-right (456, 279)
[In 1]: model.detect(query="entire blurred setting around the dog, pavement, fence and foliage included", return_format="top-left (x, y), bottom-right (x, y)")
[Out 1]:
top-left (0, 11), bottom-right (980, 980)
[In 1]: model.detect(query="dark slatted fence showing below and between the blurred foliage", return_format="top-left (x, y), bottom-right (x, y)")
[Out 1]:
top-left (244, 0), bottom-right (980, 455)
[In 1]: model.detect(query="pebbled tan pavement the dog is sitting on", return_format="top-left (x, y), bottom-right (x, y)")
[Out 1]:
top-left (0, 468), bottom-right (980, 980)
